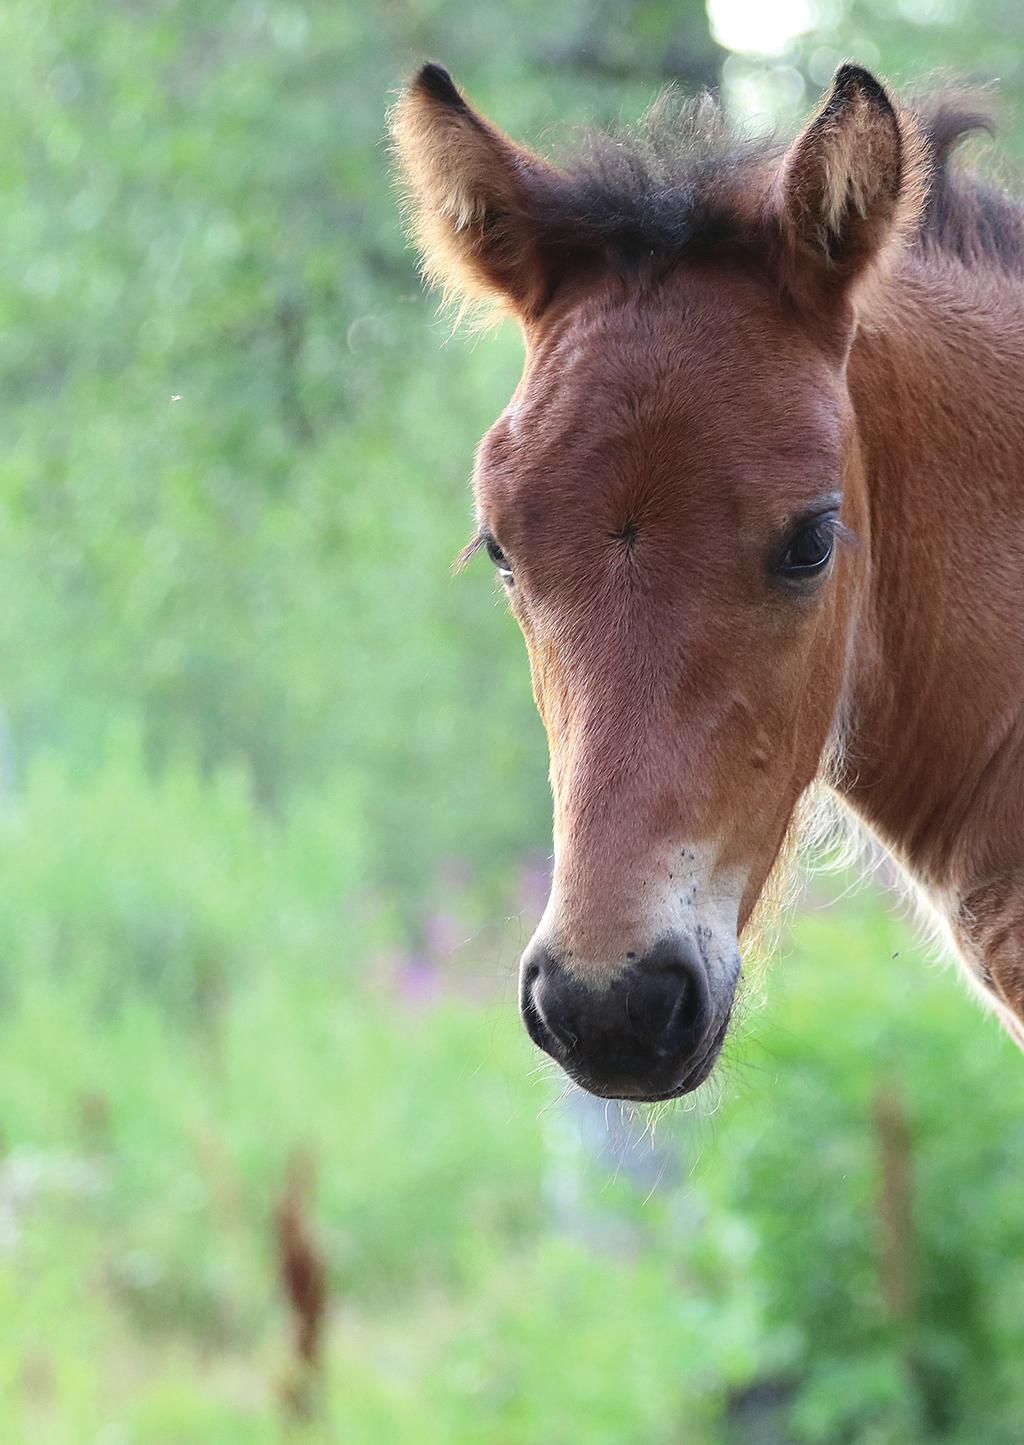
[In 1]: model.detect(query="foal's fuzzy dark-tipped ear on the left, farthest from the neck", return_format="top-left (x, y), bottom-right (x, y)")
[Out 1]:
top-left (390, 65), bottom-right (557, 319)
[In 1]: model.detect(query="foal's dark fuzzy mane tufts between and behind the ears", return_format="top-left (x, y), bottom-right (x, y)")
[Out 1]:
top-left (536, 92), bottom-right (1024, 275)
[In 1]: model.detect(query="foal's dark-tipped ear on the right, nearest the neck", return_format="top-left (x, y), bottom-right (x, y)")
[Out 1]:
top-left (774, 65), bottom-right (923, 288)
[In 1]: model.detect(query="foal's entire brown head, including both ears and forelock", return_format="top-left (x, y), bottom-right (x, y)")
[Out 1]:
top-left (393, 56), bottom-right (901, 1098)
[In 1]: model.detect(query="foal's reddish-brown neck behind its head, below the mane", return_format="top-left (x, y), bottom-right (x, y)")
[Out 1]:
top-left (841, 257), bottom-right (1024, 896)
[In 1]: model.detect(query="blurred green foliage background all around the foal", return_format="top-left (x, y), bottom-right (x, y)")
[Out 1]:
top-left (0, 0), bottom-right (1024, 1445)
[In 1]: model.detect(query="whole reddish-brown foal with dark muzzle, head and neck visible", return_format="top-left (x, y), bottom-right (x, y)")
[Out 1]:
top-left (394, 53), bottom-right (1024, 1100)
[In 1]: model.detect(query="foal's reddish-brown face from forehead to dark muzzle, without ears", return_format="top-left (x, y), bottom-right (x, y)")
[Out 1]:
top-left (475, 269), bottom-right (865, 1100)
